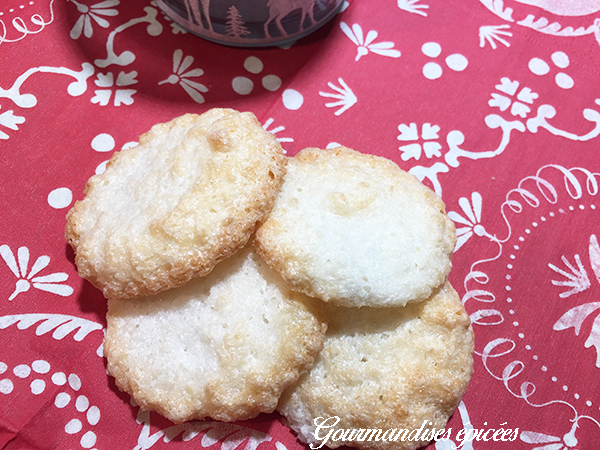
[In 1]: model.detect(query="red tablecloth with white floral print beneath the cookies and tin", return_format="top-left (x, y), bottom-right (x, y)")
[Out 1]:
top-left (0, 0), bottom-right (600, 450)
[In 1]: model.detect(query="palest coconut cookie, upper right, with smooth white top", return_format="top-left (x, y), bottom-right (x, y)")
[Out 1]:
top-left (254, 147), bottom-right (456, 307)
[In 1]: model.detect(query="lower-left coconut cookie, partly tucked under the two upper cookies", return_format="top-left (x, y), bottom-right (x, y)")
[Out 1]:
top-left (104, 246), bottom-right (325, 422)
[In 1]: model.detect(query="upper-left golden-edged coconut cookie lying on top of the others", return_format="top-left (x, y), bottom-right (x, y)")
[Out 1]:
top-left (65, 109), bottom-right (286, 298)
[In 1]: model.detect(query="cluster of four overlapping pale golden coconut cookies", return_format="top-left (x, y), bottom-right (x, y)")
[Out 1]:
top-left (66, 109), bottom-right (473, 449)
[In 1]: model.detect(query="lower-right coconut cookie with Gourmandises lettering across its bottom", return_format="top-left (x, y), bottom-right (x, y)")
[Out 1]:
top-left (278, 283), bottom-right (473, 450)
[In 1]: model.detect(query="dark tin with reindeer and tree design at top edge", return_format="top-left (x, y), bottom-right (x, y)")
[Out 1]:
top-left (156, 0), bottom-right (344, 47)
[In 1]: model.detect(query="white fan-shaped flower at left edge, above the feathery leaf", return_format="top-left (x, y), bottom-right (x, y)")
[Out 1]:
top-left (0, 244), bottom-right (73, 301)
